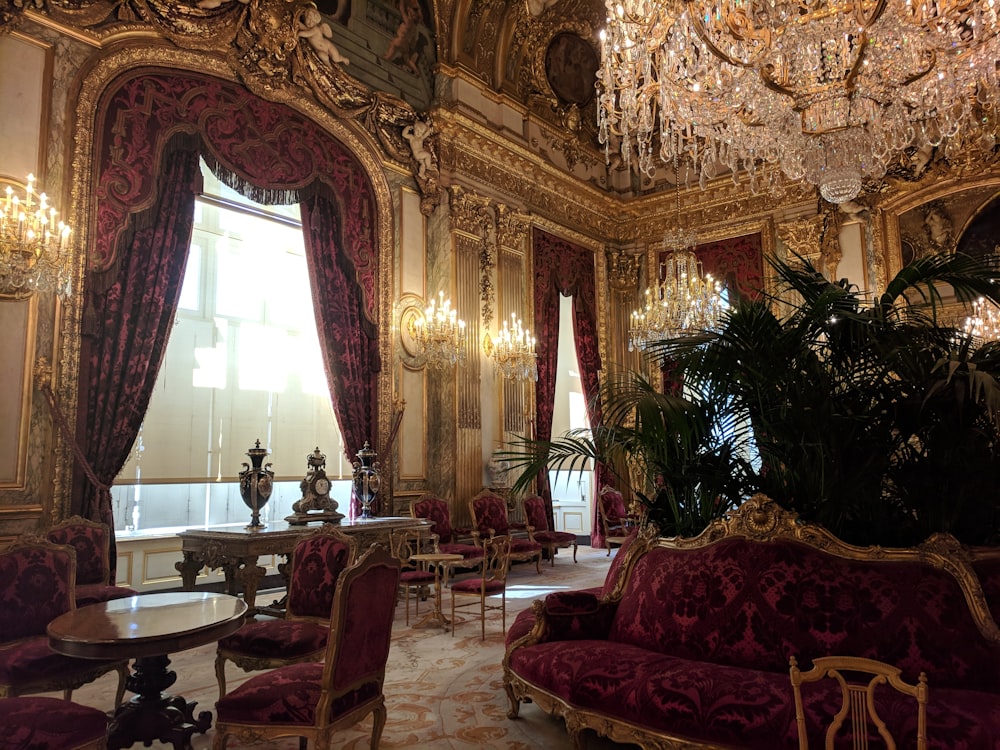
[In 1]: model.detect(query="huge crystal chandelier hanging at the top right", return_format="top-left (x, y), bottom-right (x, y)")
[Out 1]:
top-left (598, 0), bottom-right (1000, 203)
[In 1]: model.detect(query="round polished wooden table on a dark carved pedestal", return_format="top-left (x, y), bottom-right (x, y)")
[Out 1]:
top-left (48, 591), bottom-right (247, 750)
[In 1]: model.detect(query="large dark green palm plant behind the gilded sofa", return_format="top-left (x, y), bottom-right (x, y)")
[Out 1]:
top-left (503, 254), bottom-right (1000, 546)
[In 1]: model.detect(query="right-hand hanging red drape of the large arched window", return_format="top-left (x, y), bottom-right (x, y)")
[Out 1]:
top-left (300, 184), bottom-right (381, 515)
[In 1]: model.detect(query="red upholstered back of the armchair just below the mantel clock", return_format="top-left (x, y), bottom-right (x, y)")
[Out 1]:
top-left (287, 525), bottom-right (356, 620)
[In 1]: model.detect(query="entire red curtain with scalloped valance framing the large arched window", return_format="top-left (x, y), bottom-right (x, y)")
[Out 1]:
top-left (74, 70), bottom-right (380, 564)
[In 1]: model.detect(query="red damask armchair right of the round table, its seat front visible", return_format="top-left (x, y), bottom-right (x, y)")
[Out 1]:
top-left (215, 524), bottom-right (357, 698)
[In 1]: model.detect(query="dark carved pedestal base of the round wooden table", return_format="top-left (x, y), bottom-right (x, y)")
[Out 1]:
top-left (108, 656), bottom-right (212, 750)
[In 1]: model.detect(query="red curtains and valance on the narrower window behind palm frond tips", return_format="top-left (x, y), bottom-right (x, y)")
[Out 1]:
top-left (532, 229), bottom-right (610, 547)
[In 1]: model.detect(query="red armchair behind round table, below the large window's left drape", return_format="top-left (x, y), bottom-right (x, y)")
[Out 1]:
top-left (48, 516), bottom-right (139, 607)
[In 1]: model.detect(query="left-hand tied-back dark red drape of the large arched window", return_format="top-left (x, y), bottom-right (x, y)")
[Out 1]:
top-left (79, 137), bottom-right (201, 569)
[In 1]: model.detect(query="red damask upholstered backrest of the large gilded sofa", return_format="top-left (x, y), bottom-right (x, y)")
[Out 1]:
top-left (609, 539), bottom-right (1000, 692)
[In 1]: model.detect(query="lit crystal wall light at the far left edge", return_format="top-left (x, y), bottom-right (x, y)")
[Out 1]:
top-left (0, 174), bottom-right (73, 299)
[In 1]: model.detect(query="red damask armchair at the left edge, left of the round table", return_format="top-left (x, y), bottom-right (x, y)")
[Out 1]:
top-left (0, 537), bottom-right (127, 706)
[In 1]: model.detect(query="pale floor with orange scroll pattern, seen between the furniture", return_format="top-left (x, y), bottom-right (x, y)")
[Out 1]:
top-left (50, 546), bottom-right (636, 750)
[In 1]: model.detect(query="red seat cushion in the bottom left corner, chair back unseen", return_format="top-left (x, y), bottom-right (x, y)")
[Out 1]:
top-left (0, 696), bottom-right (108, 750)
